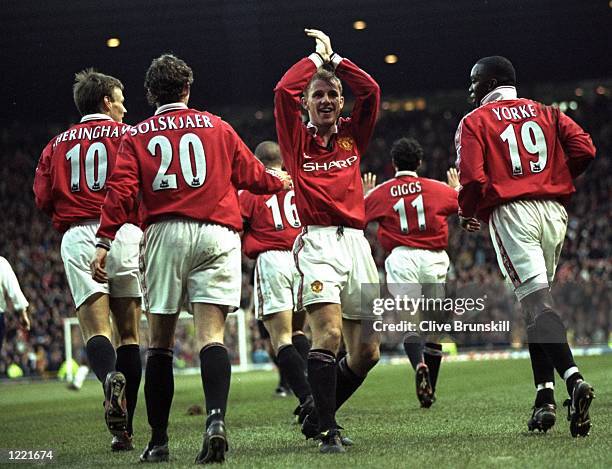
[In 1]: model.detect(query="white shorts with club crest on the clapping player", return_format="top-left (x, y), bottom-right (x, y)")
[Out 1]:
top-left (293, 225), bottom-right (380, 320)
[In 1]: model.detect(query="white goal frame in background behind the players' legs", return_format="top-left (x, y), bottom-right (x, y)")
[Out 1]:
top-left (64, 308), bottom-right (251, 381)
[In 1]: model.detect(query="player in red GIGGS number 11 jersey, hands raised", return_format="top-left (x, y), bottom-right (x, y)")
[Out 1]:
top-left (364, 138), bottom-right (459, 408)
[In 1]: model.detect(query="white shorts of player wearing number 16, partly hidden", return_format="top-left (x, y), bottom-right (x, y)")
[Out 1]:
top-left (253, 251), bottom-right (297, 319)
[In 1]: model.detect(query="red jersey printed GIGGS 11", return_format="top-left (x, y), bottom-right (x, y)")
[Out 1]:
top-left (365, 171), bottom-right (457, 251)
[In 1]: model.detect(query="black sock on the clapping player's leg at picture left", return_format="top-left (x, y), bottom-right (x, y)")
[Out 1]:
top-left (308, 349), bottom-right (338, 431)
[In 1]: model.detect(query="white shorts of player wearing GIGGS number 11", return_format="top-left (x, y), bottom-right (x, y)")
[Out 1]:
top-left (385, 246), bottom-right (450, 298)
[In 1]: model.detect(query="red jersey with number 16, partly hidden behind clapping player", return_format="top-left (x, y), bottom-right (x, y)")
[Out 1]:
top-left (239, 190), bottom-right (302, 259)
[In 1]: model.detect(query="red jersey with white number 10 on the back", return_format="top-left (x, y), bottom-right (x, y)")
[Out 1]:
top-left (33, 114), bottom-right (130, 232)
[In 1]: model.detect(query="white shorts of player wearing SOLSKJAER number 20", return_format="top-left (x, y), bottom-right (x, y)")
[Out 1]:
top-left (140, 219), bottom-right (242, 314)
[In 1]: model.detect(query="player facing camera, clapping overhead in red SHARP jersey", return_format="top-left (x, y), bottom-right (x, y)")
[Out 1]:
top-left (274, 29), bottom-right (380, 453)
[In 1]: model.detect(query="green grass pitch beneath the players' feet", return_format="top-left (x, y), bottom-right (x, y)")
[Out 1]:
top-left (0, 355), bottom-right (612, 469)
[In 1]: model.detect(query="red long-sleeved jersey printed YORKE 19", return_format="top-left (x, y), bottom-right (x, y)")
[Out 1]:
top-left (455, 86), bottom-right (595, 221)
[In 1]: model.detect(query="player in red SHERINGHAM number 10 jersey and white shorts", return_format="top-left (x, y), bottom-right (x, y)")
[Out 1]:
top-left (34, 69), bottom-right (142, 451)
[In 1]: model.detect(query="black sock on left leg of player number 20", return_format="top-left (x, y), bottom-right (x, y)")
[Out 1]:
top-left (145, 348), bottom-right (174, 446)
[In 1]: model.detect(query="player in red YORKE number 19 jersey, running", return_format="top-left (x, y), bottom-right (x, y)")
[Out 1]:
top-left (455, 56), bottom-right (595, 437)
